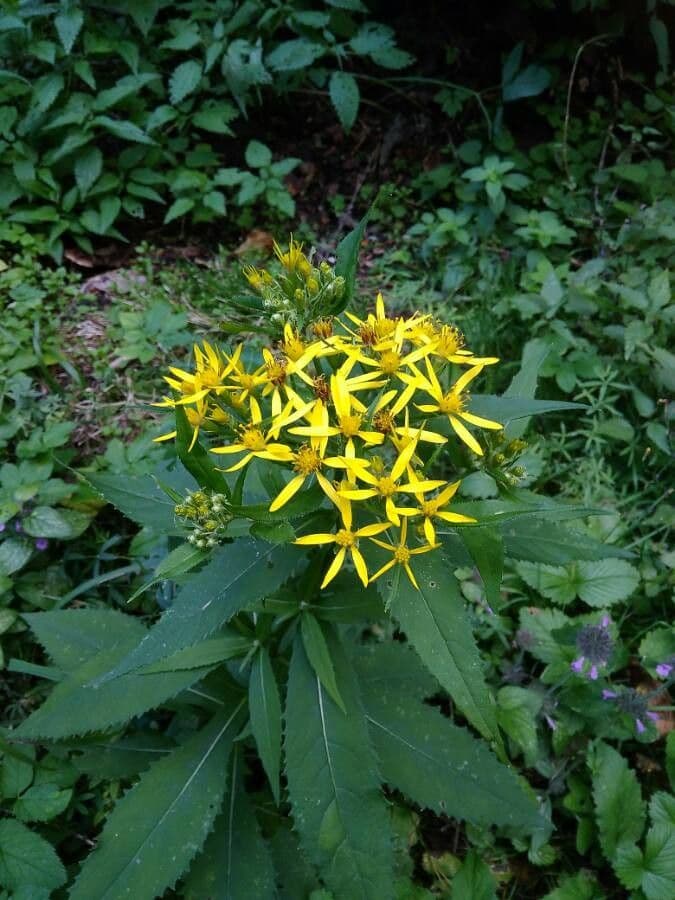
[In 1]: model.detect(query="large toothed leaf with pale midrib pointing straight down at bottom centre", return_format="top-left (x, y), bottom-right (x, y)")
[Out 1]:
top-left (285, 635), bottom-right (393, 900)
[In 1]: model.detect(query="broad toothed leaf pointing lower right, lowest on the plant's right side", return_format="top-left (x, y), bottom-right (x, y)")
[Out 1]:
top-left (362, 676), bottom-right (542, 829)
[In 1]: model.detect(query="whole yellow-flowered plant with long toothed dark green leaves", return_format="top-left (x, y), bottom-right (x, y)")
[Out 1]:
top-left (15, 223), bottom-right (616, 900)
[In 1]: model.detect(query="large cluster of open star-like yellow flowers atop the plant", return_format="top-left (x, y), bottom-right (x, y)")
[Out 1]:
top-left (157, 286), bottom-right (502, 587)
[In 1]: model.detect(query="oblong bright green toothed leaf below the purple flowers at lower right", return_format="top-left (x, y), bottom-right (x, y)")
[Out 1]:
top-left (588, 741), bottom-right (645, 862)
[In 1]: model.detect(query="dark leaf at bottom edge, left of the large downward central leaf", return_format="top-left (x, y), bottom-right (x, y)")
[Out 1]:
top-left (184, 746), bottom-right (276, 900)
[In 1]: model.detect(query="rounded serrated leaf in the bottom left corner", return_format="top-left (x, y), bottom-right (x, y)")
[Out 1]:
top-left (0, 819), bottom-right (66, 896)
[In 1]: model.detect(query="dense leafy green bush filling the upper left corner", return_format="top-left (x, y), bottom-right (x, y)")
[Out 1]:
top-left (0, 0), bottom-right (412, 258)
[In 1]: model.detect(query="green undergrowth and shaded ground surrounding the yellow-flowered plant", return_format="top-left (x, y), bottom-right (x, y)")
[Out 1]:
top-left (0, 0), bottom-right (675, 900)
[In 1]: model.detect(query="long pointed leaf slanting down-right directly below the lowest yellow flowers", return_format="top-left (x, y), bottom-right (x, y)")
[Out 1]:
top-left (377, 551), bottom-right (499, 742)
